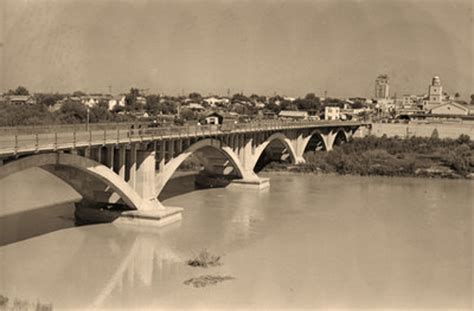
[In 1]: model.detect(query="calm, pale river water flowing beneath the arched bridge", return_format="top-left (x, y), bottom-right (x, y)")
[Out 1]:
top-left (0, 170), bottom-right (474, 310)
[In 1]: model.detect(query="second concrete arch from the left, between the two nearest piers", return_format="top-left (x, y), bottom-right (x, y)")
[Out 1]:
top-left (156, 138), bottom-right (253, 194)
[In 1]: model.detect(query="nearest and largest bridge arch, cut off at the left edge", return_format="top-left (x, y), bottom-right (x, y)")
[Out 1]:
top-left (0, 153), bottom-right (152, 210)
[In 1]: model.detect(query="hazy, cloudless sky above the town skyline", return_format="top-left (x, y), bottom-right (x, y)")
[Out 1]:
top-left (0, 0), bottom-right (474, 98)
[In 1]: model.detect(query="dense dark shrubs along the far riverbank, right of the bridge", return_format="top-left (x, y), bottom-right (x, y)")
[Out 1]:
top-left (262, 131), bottom-right (474, 179)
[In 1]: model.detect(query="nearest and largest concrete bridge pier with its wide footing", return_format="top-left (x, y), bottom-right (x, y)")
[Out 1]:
top-left (75, 143), bottom-right (182, 226)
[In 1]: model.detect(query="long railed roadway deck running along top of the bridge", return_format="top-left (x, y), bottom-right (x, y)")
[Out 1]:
top-left (0, 121), bottom-right (368, 157)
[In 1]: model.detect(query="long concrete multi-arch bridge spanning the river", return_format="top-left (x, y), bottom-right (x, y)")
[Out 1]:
top-left (0, 121), bottom-right (370, 224)
